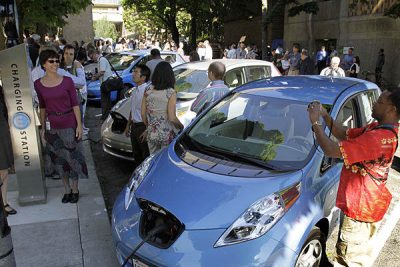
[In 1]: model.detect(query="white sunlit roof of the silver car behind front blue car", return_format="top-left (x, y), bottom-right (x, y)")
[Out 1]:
top-left (175, 59), bottom-right (273, 70)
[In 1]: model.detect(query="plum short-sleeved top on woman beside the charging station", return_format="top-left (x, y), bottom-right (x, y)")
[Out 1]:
top-left (34, 76), bottom-right (79, 129)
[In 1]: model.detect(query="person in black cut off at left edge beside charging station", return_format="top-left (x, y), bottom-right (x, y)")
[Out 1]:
top-left (0, 86), bottom-right (17, 215)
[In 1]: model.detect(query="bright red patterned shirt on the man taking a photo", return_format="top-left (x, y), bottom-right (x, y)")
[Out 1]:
top-left (336, 122), bottom-right (398, 222)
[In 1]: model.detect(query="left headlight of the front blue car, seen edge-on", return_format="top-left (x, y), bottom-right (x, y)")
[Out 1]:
top-left (125, 154), bottom-right (156, 209)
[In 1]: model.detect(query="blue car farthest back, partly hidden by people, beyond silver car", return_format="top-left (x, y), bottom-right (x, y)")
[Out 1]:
top-left (85, 50), bottom-right (185, 102)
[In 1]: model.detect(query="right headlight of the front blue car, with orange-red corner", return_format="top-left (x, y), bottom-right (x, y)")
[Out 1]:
top-left (214, 182), bottom-right (300, 247)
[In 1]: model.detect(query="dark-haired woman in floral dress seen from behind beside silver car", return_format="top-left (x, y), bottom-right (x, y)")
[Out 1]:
top-left (142, 62), bottom-right (183, 154)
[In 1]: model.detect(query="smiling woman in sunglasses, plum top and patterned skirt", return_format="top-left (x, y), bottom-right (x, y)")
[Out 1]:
top-left (34, 50), bottom-right (88, 203)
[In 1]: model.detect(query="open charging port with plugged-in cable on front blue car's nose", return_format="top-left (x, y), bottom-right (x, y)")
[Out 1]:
top-left (138, 199), bottom-right (185, 249)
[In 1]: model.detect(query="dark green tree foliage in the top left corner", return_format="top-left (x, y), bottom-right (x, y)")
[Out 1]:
top-left (16, 0), bottom-right (92, 38)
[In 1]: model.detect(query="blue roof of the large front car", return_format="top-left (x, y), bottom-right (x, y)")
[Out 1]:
top-left (234, 75), bottom-right (376, 105)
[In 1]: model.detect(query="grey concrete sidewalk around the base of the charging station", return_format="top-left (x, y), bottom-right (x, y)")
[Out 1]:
top-left (8, 142), bottom-right (118, 267)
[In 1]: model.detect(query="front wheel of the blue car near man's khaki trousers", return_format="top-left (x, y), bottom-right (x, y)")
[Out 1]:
top-left (295, 227), bottom-right (328, 267)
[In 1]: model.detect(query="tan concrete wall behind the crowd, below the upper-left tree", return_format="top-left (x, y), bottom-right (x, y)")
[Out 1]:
top-left (63, 5), bottom-right (94, 43)
